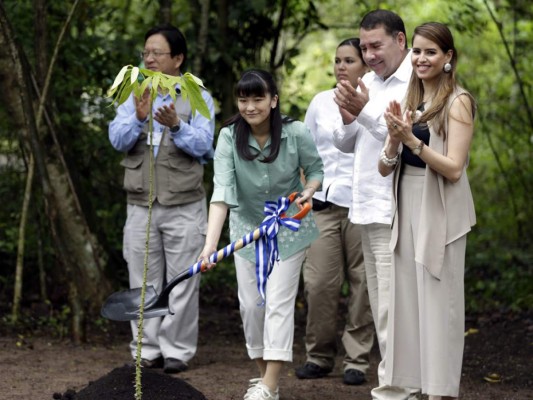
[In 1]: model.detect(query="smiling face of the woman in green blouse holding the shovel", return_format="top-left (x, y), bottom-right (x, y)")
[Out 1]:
top-left (237, 93), bottom-right (278, 134)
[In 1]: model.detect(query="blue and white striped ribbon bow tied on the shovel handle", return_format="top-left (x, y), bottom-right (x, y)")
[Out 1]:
top-left (255, 196), bottom-right (301, 305)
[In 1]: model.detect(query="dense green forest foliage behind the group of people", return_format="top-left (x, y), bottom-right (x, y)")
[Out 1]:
top-left (0, 0), bottom-right (533, 324)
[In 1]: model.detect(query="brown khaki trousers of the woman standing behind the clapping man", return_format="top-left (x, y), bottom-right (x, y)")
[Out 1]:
top-left (303, 205), bottom-right (374, 373)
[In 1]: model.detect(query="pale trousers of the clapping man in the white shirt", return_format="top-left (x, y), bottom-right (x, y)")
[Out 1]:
top-left (360, 224), bottom-right (411, 400)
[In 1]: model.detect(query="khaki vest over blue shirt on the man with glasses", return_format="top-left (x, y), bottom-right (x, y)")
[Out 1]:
top-left (120, 96), bottom-right (205, 206)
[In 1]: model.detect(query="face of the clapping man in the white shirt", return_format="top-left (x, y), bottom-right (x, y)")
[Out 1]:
top-left (359, 26), bottom-right (406, 80)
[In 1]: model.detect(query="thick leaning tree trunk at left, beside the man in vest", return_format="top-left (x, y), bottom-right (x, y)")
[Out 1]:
top-left (0, 3), bottom-right (111, 341)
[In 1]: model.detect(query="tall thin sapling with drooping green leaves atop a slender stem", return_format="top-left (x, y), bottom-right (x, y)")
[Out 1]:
top-left (108, 65), bottom-right (211, 400)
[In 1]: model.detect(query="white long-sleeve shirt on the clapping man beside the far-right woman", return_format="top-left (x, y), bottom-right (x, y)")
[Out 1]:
top-left (333, 53), bottom-right (413, 225)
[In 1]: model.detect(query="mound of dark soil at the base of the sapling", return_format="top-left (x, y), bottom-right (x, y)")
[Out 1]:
top-left (53, 365), bottom-right (207, 400)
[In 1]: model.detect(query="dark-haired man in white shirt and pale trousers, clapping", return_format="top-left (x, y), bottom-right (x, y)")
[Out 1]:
top-left (333, 10), bottom-right (419, 400)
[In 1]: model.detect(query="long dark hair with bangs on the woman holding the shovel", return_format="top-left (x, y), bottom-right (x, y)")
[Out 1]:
top-left (223, 69), bottom-right (292, 163)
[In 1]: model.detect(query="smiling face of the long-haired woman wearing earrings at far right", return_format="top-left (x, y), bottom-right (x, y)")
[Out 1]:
top-left (411, 35), bottom-right (453, 83)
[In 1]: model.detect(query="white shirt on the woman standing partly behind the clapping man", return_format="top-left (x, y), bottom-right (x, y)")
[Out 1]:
top-left (304, 89), bottom-right (354, 208)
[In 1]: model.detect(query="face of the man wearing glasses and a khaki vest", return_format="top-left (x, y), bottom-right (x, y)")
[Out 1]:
top-left (143, 33), bottom-right (183, 76)
